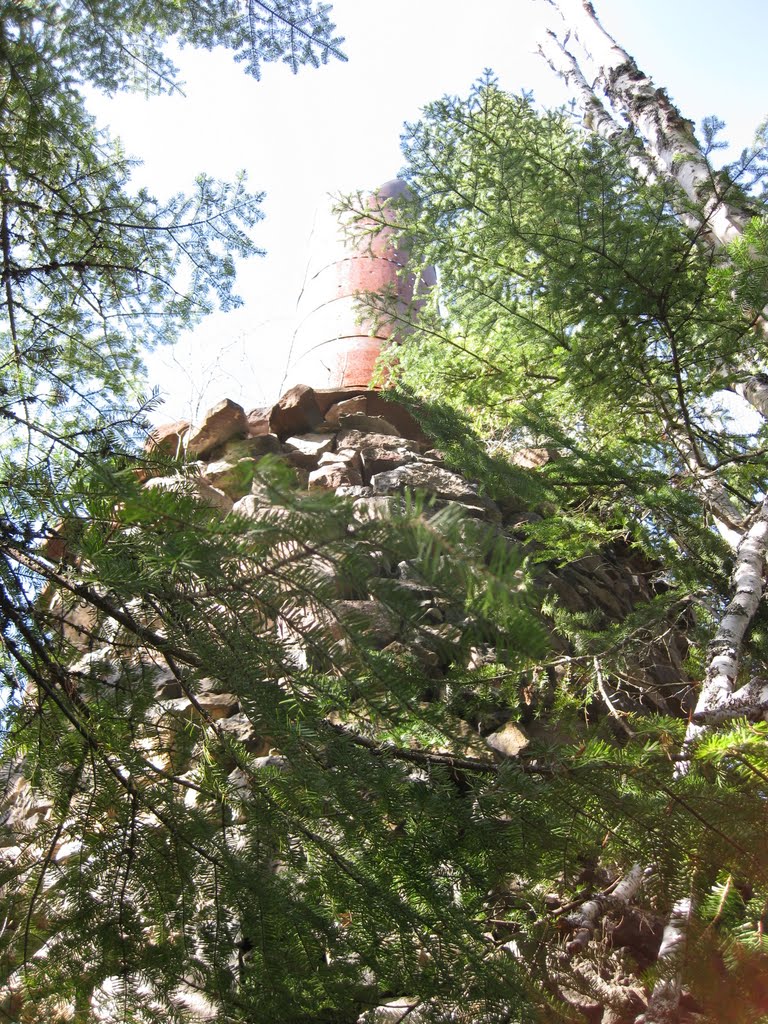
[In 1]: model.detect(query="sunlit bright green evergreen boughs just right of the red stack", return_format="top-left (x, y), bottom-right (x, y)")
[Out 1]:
top-left (381, 79), bottom-right (768, 577)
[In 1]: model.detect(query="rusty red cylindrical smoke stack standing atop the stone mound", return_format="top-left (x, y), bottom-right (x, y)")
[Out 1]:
top-left (284, 178), bottom-right (435, 388)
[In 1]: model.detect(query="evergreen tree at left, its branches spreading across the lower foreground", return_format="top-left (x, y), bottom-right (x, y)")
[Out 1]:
top-left (0, 3), bottom-right (552, 1021)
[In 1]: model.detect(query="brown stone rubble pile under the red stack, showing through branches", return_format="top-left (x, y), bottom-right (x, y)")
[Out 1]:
top-left (0, 386), bottom-right (686, 1024)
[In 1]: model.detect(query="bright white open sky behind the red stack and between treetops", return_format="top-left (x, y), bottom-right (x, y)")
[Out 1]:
top-left (87, 0), bottom-right (768, 421)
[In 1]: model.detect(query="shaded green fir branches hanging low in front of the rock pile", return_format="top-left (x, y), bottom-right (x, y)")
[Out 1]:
top-left (3, 463), bottom-right (561, 1021)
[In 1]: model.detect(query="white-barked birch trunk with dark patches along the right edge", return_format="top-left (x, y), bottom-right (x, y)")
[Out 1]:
top-left (541, 6), bottom-right (768, 1024)
